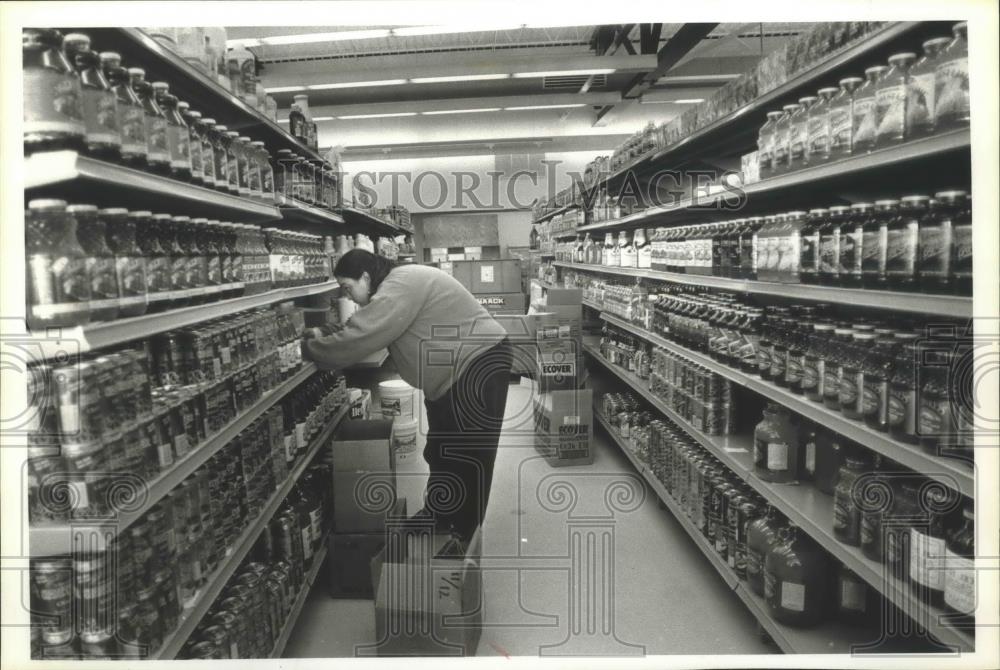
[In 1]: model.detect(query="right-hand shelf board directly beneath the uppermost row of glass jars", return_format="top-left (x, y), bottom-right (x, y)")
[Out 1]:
top-left (577, 129), bottom-right (971, 232)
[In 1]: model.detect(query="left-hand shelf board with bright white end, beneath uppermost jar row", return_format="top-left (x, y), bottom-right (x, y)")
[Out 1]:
top-left (24, 151), bottom-right (281, 223)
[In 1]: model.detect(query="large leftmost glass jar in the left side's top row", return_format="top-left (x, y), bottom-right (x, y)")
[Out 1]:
top-left (21, 28), bottom-right (87, 154)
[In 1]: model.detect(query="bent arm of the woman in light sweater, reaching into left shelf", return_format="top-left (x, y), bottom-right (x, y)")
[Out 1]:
top-left (302, 274), bottom-right (424, 369)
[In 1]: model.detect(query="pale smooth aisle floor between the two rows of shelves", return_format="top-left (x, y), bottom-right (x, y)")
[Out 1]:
top-left (285, 386), bottom-right (774, 658)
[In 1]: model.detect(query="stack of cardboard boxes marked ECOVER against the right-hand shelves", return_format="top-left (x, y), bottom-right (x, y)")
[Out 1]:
top-left (532, 289), bottom-right (594, 466)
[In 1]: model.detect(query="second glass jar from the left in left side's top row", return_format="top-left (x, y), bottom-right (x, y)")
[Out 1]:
top-left (63, 33), bottom-right (122, 162)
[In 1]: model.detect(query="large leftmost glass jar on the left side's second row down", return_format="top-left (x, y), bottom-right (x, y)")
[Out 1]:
top-left (24, 199), bottom-right (90, 330)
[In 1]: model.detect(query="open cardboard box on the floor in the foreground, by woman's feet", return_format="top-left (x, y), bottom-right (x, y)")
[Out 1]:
top-left (373, 529), bottom-right (483, 656)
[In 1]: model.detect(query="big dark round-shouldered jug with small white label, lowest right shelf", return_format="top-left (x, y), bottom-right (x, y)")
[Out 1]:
top-left (764, 524), bottom-right (829, 627)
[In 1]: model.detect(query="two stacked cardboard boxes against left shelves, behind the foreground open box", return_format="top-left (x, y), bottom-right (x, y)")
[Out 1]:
top-left (329, 420), bottom-right (406, 598)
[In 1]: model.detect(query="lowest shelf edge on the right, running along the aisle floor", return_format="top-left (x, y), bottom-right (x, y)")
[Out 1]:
top-left (594, 412), bottom-right (884, 654)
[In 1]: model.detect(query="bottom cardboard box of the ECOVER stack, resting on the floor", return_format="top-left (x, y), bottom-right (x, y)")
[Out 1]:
top-left (533, 389), bottom-right (594, 466)
